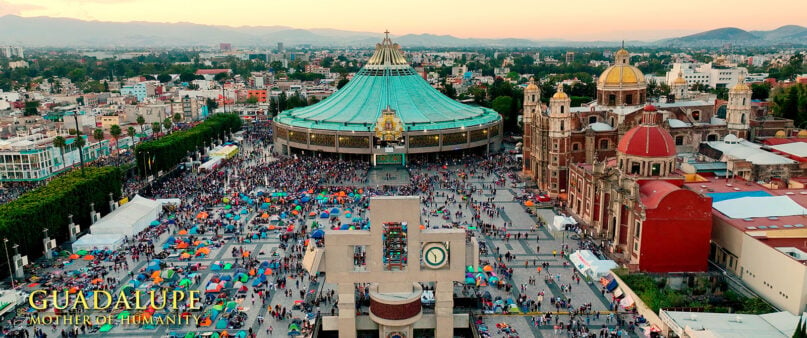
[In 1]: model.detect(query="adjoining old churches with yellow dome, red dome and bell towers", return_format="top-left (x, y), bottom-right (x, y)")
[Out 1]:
top-left (523, 49), bottom-right (753, 272)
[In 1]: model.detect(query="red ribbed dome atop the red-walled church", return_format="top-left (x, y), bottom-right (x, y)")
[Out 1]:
top-left (617, 125), bottom-right (676, 157)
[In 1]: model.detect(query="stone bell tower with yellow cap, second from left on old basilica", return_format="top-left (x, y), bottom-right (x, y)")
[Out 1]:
top-left (547, 83), bottom-right (572, 196)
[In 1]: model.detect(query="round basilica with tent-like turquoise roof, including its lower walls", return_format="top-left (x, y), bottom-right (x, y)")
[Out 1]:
top-left (274, 35), bottom-right (502, 165)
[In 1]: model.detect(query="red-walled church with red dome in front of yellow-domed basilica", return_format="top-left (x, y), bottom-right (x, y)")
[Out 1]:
top-left (564, 107), bottom-right (712, 272)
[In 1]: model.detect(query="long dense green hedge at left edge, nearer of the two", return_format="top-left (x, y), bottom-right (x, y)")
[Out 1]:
top-left (0, 166), bottom-right (122, 273)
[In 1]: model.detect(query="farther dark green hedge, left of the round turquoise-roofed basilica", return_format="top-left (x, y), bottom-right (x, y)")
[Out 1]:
top-left (135, 114), bottom-right (241, 176)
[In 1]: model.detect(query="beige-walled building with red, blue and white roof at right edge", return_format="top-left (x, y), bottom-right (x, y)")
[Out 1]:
top-left (686, 175), bottom-right (807, 315)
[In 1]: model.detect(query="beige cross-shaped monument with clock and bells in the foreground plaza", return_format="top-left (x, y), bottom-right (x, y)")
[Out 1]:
top-left (303, 196), bottom-right (479, 337)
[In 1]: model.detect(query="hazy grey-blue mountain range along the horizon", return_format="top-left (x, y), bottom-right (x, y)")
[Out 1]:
top-left (0, 15), bottom-right (807, 48)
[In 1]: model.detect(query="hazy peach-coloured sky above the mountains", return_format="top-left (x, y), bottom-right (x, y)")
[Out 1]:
top-left (0, 0), bottom-right (807, 40)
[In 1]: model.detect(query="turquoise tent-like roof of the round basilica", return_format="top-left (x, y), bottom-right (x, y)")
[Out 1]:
top-left (275, 36), bottom-right (501, 131)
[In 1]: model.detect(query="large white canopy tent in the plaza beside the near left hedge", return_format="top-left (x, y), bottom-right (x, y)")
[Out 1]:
top-left (90, 195), bottom-right (162, 237)
